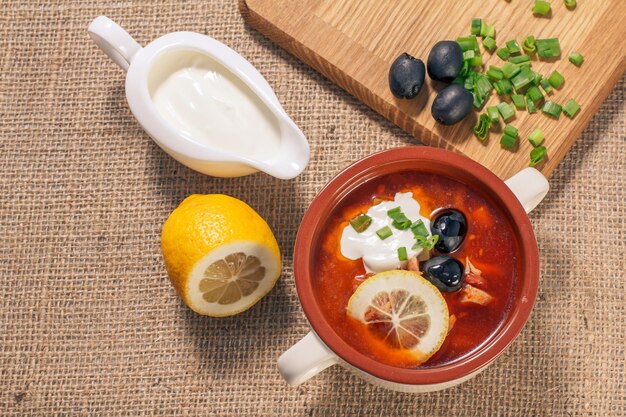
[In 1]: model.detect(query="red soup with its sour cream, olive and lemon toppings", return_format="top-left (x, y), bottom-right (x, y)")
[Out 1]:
top-left (312, 171), bottom-right (522, 368)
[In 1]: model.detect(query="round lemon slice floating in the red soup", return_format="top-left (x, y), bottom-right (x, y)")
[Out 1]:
top-left (348, 270), bottom-right (449, 364)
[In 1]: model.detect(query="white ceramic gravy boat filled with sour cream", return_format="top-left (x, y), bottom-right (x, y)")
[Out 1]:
top-left (88, 16), bottom-right (309, 179)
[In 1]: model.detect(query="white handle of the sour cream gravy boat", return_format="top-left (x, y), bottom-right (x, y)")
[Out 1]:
top-left (87, 16), bottom-right (141, 71)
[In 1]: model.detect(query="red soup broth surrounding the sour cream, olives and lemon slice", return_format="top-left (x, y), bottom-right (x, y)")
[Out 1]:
top-left (314, 172), bottom-right (521, 368)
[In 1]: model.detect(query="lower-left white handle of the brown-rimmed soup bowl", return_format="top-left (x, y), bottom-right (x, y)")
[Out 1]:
top-left (278, 331), bottom-right (339, 386)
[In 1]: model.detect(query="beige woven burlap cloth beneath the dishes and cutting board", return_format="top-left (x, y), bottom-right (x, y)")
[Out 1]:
top-left (0, 0), bottom-right (626, 417)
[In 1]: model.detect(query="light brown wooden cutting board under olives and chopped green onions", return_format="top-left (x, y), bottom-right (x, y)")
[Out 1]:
top-left (240, 0), bottom-right (626, 178)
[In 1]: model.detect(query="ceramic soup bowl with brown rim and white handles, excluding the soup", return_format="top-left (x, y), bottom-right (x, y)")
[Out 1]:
top-left (278, 146), bottom-right (548, 392)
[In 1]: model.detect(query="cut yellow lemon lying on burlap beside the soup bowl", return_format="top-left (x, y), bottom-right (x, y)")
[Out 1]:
top-left (161, 194), bottom-right (281, 317)
